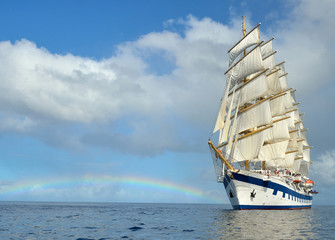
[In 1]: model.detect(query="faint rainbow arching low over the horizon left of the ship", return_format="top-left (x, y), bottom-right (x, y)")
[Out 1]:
top-left (0, 176), bottom-right (223, 203)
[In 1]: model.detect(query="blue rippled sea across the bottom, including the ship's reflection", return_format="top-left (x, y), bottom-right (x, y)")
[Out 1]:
top-left (0, 202), bottom-right (335, 240)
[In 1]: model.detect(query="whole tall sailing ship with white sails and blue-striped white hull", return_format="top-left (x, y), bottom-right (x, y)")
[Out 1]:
top-left (208, 17), bottom-right (317, 210)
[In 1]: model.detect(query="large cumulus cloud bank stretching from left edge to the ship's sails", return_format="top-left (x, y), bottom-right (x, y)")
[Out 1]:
top-left (0, 16), bottom-right (237, 155)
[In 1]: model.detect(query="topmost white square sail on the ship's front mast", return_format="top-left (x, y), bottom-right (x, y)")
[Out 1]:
top-left (228, 25), bottom-right (260, 66)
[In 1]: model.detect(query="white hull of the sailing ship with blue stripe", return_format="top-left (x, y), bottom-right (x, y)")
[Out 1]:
top-left (223, 170), bottom-right (313, 210)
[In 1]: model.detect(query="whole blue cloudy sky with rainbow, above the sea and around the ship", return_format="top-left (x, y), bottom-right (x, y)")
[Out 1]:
top-left (0, 0), bottom-right (335, 204)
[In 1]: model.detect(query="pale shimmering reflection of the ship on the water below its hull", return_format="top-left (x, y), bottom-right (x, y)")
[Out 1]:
top-left (209, 209), bottom-right (320, 239)
